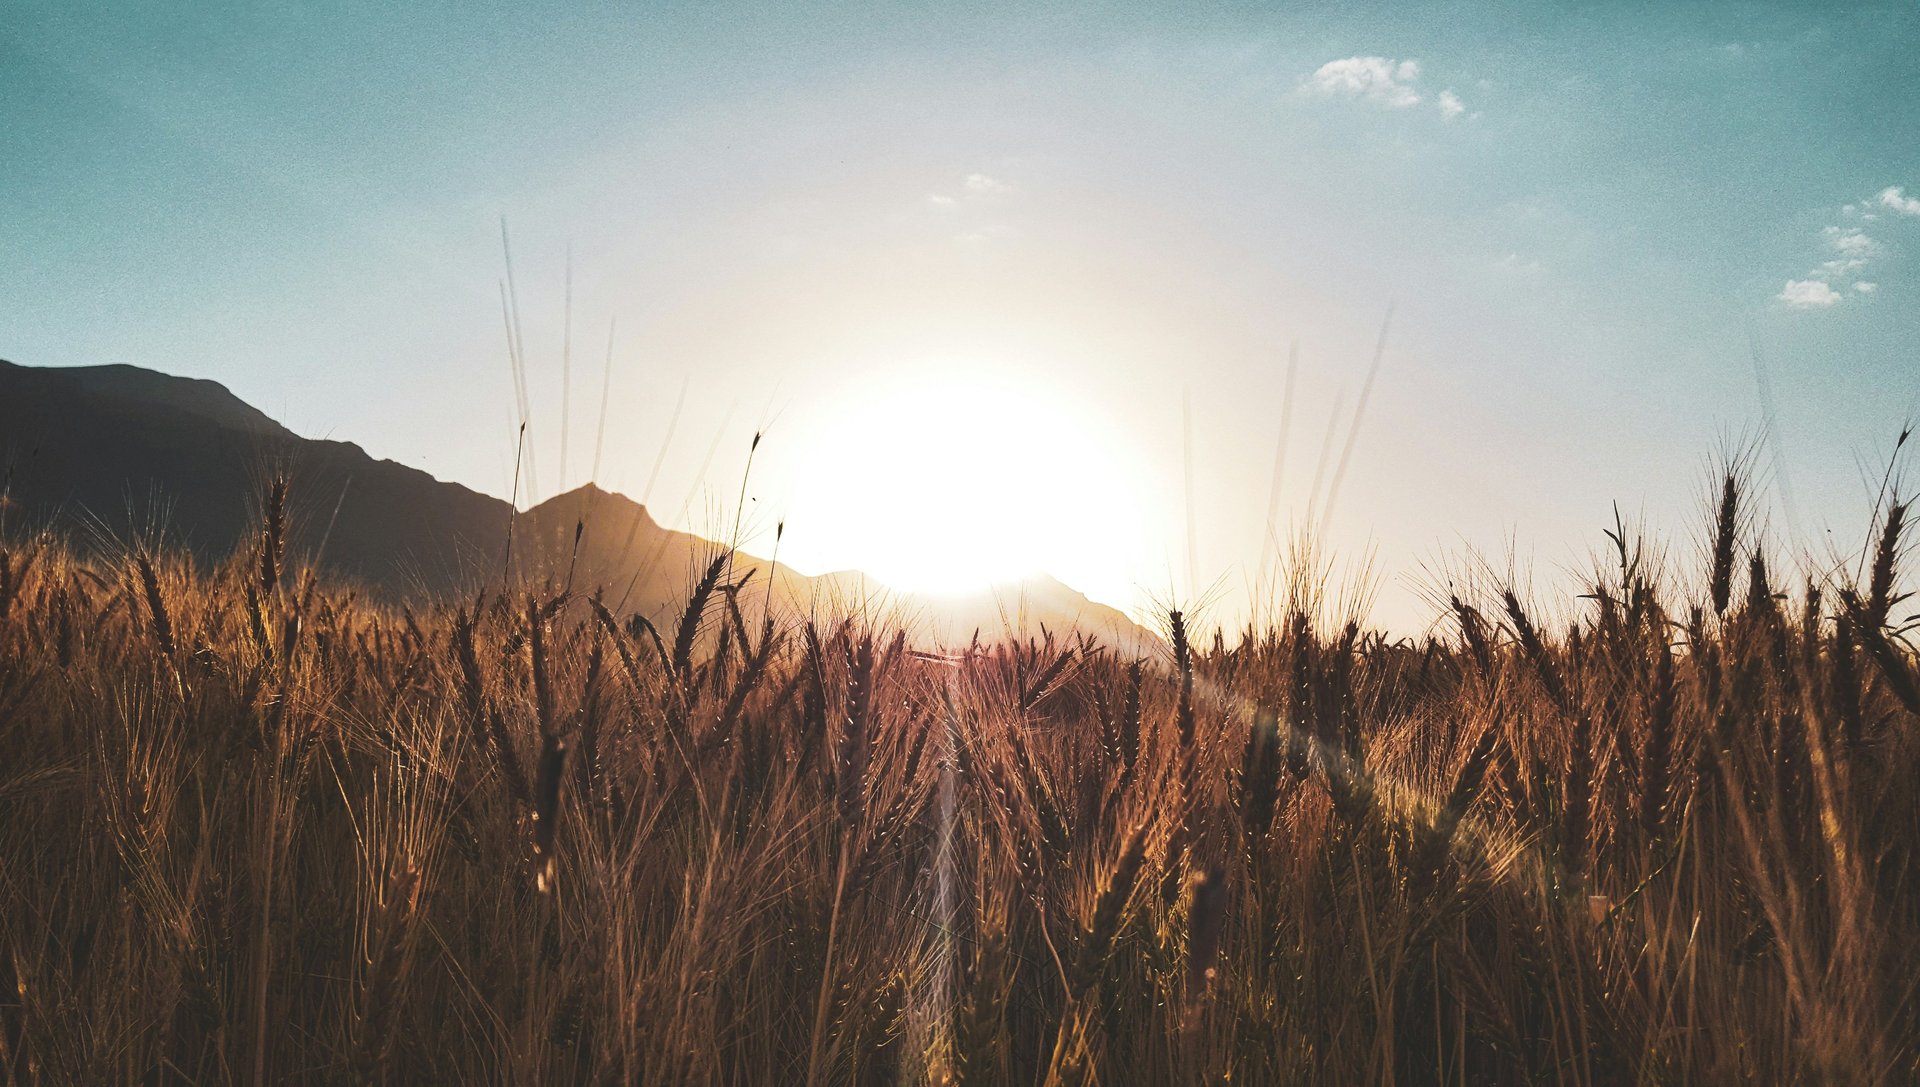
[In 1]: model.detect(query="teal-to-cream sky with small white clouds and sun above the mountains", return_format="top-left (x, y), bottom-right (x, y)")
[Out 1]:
top-left (0, 0), bottom-right (1920, 632)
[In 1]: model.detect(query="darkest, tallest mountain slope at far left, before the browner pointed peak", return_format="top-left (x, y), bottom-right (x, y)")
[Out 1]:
top-left (0, 357), bottom-right (507, 592)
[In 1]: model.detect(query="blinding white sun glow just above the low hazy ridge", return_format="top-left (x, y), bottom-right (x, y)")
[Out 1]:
top-left (768, 363), bottom-right (1144, 605)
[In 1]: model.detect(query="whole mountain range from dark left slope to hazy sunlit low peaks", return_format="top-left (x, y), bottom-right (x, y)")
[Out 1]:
top-left (0, 361), bottom-right (1154, 649)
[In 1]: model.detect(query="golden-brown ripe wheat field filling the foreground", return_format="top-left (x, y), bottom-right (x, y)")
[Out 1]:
top-left (0, 476), bottom-right (1920, 1083)
